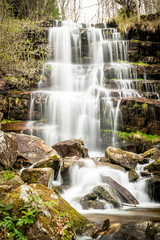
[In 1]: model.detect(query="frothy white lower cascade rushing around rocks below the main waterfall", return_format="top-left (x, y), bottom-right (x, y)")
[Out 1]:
top-left (62, 159), bottom-right (159, 214)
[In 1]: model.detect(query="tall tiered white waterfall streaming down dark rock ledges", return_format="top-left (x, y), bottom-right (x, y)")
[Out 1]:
top-left (30, 22), bottom-right (140, 155)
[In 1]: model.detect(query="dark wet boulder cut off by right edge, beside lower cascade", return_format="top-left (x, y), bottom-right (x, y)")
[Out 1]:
top-left (147, 177), bottom-right (160, 202)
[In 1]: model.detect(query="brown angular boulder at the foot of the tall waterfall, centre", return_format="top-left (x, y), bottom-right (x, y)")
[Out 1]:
top-left (52, 139), bottom-right (88, 158)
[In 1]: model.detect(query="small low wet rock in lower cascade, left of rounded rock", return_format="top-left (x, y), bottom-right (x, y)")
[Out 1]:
top-left (80, 193), bottom-right (105, 209)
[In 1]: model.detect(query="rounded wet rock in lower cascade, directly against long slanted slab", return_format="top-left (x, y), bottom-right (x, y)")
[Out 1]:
top-left (93, 186), bottom-right (120, 208)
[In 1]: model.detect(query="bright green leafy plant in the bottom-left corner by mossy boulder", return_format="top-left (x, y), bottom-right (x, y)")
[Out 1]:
top-left (0, 204), bottom-right (38, 240)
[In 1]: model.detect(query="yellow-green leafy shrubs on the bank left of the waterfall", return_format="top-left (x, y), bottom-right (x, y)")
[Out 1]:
top-left (0, 17), bottom-right (48, 90)
